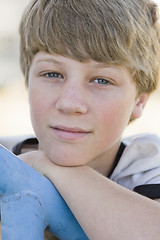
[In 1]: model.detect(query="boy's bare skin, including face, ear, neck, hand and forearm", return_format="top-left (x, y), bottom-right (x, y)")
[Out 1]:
top-left (20, 52), bottom-right (160, 240)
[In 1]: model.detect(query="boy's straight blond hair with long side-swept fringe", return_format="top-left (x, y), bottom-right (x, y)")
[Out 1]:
top-left (20, 0), bottom-right (160, 93)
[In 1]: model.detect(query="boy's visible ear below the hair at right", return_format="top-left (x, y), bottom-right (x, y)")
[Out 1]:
top-left (132, 93), bottom-right (149, 119)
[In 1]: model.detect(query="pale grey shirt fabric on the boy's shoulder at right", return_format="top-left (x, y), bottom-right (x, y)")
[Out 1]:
top-left (111, 134), bottom-right (160, 190)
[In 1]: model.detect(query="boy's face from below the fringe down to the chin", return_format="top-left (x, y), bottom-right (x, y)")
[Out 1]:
top-left (29, 52), bottom-right (144, 172)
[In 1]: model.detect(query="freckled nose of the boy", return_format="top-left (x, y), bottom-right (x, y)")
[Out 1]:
top-left (56, 85), bottom-right (88, 114)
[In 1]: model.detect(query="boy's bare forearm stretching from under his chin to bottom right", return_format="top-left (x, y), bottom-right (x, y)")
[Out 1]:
top-left (48, 166), bottom-right (160, 240)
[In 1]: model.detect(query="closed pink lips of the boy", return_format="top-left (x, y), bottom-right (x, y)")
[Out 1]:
top-left (51, 126), bottom-right (91, 140)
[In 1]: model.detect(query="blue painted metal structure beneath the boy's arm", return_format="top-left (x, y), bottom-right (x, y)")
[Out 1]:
top-left (0, 145), bottom-right (88, 240)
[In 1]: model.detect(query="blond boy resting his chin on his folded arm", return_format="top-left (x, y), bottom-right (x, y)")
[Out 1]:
top-left (9, 0), bottom-right (160, 240)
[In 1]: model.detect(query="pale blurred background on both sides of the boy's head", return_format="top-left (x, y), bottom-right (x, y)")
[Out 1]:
top-left (0, 0), bottom-right (160, 136)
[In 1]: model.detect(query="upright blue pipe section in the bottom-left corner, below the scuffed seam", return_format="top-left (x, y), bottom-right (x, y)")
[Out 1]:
top-left (2, 192), bottom-right (46, 240)
